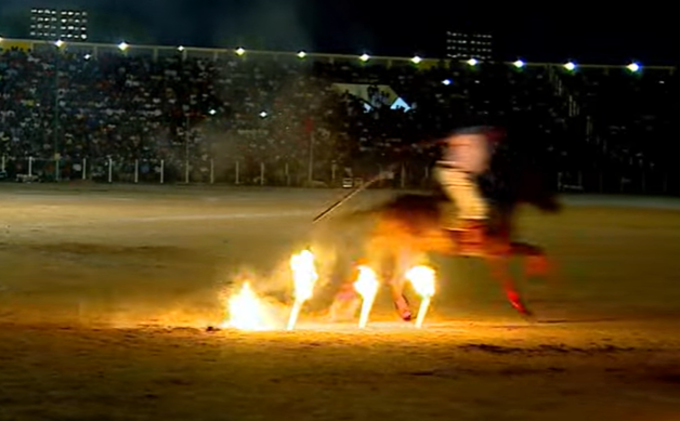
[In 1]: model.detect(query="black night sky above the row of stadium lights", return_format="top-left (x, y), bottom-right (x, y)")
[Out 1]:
top-left (0, 0), bottom-right (678, 64)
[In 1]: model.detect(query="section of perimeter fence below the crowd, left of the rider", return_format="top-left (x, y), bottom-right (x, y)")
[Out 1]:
top-left (0, 156), bottom-right (429, 188)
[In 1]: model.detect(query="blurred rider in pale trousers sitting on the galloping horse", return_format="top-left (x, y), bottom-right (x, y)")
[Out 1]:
top-left (434, 127), bottom-right (500, 250)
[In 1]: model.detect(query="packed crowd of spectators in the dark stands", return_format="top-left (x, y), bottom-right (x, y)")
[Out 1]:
top-left (0, 41), bottom-right (678, 193)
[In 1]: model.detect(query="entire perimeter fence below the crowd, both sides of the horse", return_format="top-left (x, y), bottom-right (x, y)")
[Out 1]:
top-left (0, 156), bottom-right (680, 195)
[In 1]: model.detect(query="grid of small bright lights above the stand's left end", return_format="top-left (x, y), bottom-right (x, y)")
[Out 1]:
top-left (30, 7), bottom-right (88, 41)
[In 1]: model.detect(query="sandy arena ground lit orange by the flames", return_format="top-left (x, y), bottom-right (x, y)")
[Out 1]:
top-left (0, 185), bottom-right (680, 421)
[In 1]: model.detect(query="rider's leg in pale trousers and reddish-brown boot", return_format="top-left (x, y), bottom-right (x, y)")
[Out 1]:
top-left (435, 166), bottom-right (488, 243)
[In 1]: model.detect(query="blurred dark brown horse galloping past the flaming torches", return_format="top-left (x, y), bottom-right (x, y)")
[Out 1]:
top-left (326, 141), bottom-right (562, 321)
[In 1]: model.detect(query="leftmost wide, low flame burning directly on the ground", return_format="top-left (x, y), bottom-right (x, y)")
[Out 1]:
top-left (222, 282), bottom-right (273, 330)
